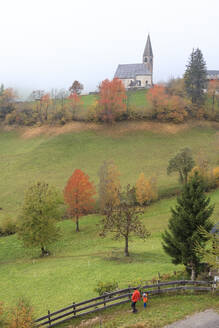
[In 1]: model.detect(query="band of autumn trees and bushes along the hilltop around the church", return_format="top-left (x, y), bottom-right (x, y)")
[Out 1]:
top-left (0, 49), bottom-right (219, 125)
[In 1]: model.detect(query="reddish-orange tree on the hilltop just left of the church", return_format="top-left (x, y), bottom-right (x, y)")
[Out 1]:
top-left (98, 78), bottom-right (127, 123)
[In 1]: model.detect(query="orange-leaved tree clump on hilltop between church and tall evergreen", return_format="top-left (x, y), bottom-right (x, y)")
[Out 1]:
top-left (147, 85), bottom-right (188, 123)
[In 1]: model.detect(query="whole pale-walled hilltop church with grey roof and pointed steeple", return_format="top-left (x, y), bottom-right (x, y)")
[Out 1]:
top-left (114, 35), bottom-right (153, 89)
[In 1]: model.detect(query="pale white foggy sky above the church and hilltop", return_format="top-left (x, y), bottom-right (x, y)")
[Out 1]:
top-left (0, 0), bottom-right (219, 93)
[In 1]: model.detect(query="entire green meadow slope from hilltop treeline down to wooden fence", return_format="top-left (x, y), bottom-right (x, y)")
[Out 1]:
top-left (0, 122), bottom-right (219, 316)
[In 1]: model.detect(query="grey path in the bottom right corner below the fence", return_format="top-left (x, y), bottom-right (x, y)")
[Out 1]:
top-left (164, 310), bottom-right (219, 328)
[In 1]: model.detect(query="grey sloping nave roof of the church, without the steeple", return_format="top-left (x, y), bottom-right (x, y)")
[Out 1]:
top-left (114, 64), bottom-right (151, 79)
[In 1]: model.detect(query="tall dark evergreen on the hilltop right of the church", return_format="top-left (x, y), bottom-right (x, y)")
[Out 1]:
top-left (184, 48), bottom-right (207, 105)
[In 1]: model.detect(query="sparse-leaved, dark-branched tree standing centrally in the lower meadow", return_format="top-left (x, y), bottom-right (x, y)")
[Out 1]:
top-left (100, 185), bottom-right (150, 256)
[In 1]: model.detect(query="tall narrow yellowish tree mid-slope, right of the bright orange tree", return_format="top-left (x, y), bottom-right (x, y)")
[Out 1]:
top-left (99, 161), bottom-right (121, 214)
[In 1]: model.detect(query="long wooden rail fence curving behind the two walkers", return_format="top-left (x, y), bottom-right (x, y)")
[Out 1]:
top-left (35, 280), bottom-right (217, 327)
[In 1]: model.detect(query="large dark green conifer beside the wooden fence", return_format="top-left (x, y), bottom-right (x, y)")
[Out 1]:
top-left (162, 173), bottom-right (214, 280)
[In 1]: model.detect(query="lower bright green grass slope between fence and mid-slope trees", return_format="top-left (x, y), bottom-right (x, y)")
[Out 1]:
top-left (0, 190), bottom-right (219, 315)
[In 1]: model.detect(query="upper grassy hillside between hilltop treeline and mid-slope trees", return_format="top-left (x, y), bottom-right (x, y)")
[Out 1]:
top-left (0, 122), bottom-right (219, 218)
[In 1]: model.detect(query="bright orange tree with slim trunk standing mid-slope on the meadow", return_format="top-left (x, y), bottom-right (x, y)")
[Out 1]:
top-left (64, 169), bottom-right (96, 232)
